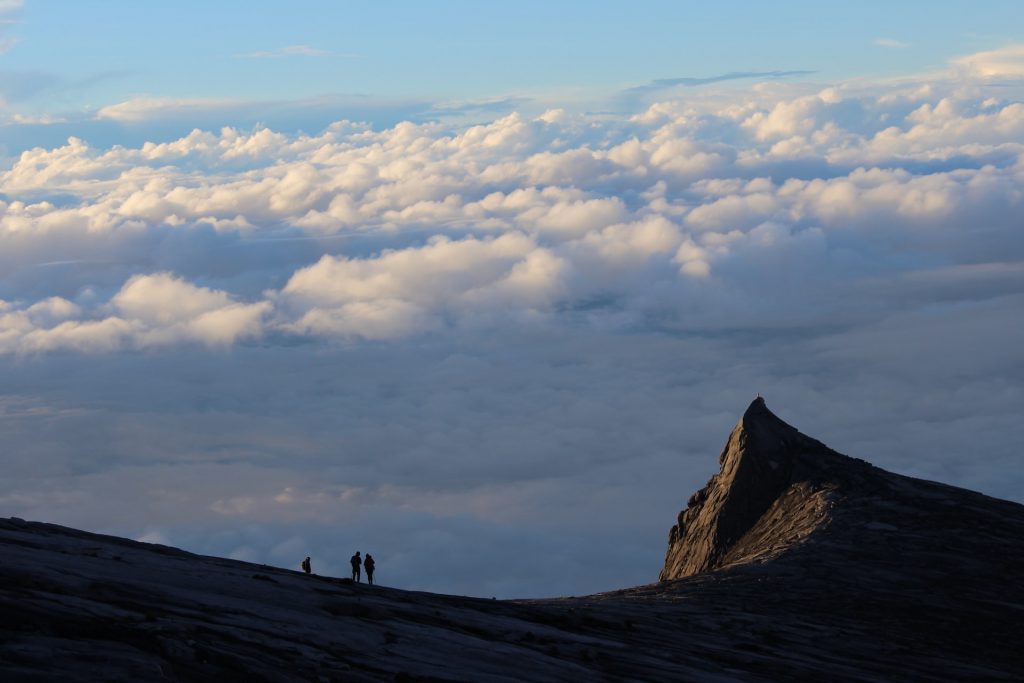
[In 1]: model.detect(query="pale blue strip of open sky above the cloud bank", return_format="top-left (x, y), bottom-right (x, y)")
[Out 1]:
top-left (2, 0), bottom-right (1021, 114)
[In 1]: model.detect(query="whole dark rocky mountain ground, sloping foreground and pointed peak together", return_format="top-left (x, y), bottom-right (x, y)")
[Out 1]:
top-left (0, 399), bottom-right (1024, 682)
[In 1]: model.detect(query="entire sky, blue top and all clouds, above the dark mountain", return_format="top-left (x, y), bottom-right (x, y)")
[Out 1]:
top-left (0, 0), bottom-right (1024, 597)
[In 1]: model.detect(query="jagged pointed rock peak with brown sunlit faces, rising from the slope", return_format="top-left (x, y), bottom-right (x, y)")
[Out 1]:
top-left (659, 397), bottom-right (881, 581)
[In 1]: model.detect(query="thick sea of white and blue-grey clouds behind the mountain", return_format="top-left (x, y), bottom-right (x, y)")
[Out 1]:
top-left (0, 47), bottom-right (1024, 596)
